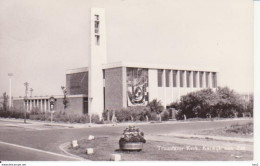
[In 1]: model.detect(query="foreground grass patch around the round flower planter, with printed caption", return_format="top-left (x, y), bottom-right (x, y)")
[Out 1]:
top-left (67, 137), bottom-right (253, 161)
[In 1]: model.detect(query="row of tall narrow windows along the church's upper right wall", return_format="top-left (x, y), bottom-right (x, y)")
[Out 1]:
top-left (158, 69), bottom-right (217, 88)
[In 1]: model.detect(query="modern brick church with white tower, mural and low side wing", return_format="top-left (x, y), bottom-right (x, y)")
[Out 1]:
top-left (14, 8), bottom-right (218, 117)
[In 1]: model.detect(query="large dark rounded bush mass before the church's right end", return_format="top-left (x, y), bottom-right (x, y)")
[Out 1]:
top-left (170, 87), bottom-right (253, 119)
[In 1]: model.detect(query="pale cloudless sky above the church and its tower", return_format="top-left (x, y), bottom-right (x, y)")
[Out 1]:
top-left (0, 0), bottom-right (253, 97)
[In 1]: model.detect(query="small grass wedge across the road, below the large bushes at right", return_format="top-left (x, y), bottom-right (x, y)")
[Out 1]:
top-left (196, 122), bottom-right (254, 138)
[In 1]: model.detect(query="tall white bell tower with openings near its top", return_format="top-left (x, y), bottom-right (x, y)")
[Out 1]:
top-left (88, 8), bottom-right (107, 117)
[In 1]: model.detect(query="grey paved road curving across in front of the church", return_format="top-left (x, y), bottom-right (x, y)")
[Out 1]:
top-left (0, 120), bottom-right (252, 160)
